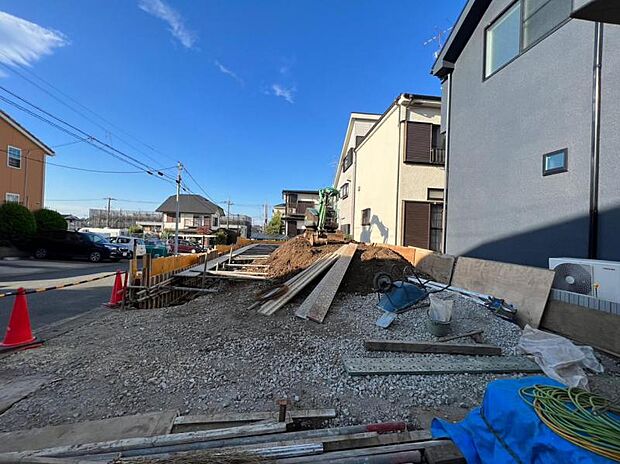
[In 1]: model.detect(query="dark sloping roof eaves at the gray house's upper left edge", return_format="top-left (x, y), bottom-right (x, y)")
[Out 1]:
top-left (431, 0), bottom-right (491, 79)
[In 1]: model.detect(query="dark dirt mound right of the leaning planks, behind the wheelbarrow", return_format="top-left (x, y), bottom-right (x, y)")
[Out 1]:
top-left (339, 244), bottom-right (412, 294)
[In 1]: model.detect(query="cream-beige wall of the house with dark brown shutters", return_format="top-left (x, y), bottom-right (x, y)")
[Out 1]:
top-left (349, 98), bottom-right (445, 245)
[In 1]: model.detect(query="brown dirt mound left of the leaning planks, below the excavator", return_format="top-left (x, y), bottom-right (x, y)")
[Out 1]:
top-left (264, 236), bottom-right (342, 280)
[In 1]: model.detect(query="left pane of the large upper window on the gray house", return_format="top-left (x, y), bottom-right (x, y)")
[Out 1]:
top-left (484, 2), bottom-right (521, 77)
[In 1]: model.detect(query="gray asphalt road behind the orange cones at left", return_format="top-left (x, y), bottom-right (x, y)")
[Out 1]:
top-left (0, 259), bottom-right (127, 332)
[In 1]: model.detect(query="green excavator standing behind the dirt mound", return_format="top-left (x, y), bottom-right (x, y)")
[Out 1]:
top-left (304, 187), bottom-right (345, 246)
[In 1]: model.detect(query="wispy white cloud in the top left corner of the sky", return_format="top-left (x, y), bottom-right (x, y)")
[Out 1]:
top-left (0, 11), bottom-right (69, 66)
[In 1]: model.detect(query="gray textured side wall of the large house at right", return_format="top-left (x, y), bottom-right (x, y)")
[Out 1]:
top-left (443, 0), bottom-right (620, 267)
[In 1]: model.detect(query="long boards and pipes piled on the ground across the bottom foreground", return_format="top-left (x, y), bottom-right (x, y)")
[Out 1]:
top-left (0, 410), bottom-right (464, 464)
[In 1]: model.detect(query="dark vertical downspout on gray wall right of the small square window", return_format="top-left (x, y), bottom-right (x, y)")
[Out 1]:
top-left (588, 22), bottom-right (603, 259)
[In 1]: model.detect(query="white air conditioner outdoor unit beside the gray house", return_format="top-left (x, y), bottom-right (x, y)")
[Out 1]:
top-left (549, 258), bottom-right (620, 303)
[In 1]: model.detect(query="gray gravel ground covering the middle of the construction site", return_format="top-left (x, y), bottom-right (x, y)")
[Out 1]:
top-left (0, 283), bottom-right (612, 431)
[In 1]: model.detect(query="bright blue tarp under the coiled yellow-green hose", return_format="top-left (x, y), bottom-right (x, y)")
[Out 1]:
top-left (431, 377), bottom-right (612, 464)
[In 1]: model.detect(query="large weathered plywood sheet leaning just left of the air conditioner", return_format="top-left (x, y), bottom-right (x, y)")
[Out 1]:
top-left (452, 257), bottom-right (555, 328)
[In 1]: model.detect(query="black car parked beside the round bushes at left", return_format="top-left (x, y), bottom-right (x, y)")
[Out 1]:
top-left (29, 231), bottom-right (129, 263)
